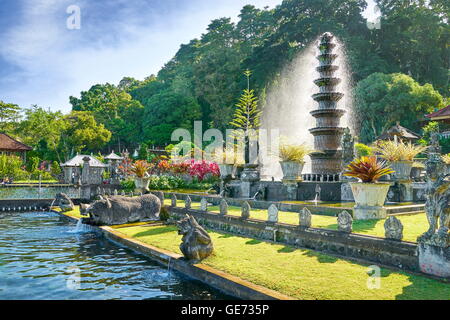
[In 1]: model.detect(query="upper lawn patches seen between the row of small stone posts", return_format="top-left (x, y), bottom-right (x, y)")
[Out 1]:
top-left (164, 199), bottom-right (428, 242)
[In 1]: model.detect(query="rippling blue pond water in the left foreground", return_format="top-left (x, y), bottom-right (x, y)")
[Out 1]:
top-left (0, 212), bottom-right (231, 300)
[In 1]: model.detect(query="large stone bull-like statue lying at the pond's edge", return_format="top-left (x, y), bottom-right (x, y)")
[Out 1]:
top-left (80, 194), bottom-right (161, 225)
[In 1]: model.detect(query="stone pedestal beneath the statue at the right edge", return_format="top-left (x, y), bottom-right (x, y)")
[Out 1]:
top-left (418, 242), bottom-right (450, 278)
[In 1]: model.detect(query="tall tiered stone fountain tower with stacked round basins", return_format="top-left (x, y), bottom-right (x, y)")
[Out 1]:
top-left (310, 33), bottom-right (345, 175)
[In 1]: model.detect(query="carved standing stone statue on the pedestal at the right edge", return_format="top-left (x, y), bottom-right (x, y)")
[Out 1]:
top-left (417, 153), bottom-right (450, 248)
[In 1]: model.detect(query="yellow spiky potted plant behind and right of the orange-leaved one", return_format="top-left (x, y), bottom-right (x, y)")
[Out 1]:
top-left (375, 141), bottom-right (427, 180)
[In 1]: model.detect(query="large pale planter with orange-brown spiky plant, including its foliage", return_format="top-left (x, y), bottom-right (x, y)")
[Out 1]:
top-left (344, 156), bottom-right (393, 220)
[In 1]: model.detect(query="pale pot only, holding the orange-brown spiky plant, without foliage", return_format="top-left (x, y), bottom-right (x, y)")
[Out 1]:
top-left (350, 182), bottom-right (390, 220)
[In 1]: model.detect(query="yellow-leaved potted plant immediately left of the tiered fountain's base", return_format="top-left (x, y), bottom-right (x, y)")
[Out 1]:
top-left (279, 143), bottom-right (313, 181)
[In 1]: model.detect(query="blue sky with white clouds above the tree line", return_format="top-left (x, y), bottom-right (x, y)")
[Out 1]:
top-left (0, 0), bottom-right (380, 113)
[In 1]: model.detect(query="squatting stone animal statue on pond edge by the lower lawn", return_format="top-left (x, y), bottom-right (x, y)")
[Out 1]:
top-left (177, 215), bottom-right (214, 262)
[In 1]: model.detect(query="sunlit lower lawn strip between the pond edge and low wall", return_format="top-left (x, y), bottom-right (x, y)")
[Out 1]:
top-left (118, 226), bottom-right (450, 300)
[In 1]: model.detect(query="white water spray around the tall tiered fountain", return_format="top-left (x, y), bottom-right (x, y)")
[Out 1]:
top-left (260, 33), bottom-right (354, 180)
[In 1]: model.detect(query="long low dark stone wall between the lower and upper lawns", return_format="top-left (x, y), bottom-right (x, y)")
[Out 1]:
top-left (170, 207), bottom-right (420, 272)
